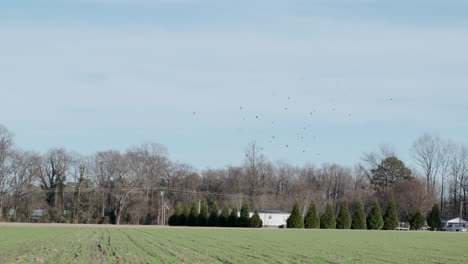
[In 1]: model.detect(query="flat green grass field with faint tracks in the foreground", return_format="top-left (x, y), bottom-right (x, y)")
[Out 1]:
top-left (0, 227), bottom-right (468, 263)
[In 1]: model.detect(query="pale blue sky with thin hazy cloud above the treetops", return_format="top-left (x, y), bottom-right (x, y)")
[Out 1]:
top-left (0, 0), bottom-right (468, 169)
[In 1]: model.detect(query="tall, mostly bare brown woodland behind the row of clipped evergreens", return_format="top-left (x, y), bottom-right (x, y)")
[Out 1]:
top-left (0, 125), bottom-right (468, 224)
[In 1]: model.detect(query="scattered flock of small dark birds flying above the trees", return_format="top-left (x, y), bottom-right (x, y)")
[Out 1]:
top-left (192, 96), bottom-right (393, 156)
